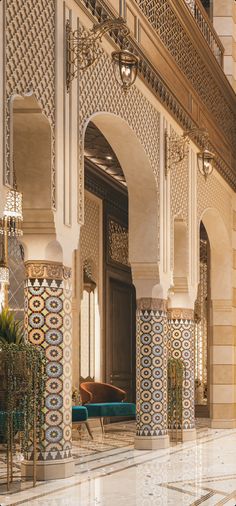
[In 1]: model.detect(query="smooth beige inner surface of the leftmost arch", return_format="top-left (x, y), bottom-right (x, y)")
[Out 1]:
top-left (11, 95), bottom-right (54, 233)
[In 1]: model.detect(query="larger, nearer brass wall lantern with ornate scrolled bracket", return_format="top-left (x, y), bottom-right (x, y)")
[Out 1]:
top-left (66, 18), bottom-right (139, 92)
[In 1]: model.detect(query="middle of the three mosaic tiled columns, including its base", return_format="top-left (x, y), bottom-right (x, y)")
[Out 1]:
top-left (135, 298), bottom-right (169, 450)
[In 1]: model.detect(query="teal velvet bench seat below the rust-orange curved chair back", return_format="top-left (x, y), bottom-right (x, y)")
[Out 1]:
top-left (85, 402), bottom-right (136, 432)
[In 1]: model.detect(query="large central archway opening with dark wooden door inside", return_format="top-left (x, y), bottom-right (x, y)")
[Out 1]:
top-left (80, 113), bottom-right (158, 401)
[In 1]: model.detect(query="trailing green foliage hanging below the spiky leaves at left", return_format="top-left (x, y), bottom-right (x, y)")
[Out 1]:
top-left (0, 342), bottom-right (46, 458)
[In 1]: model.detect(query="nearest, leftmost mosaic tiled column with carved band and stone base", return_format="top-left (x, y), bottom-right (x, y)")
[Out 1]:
top-left (22, 262), bottom-right (74, 479)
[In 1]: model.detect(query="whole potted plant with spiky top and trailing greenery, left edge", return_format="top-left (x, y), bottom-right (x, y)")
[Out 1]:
top-left (0, 309), bottom-right (45, 451)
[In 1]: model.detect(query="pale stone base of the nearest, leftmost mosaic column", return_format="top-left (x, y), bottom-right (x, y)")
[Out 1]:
top-left (21, 457), bottom-right (75, 481)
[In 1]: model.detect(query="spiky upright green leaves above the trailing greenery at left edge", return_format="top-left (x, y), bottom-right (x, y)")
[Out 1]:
top-left (0, 309), bottom-right (25, 347)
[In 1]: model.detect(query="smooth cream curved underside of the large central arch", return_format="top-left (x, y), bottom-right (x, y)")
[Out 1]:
top-left (84, 112), bottom-right (159, 265)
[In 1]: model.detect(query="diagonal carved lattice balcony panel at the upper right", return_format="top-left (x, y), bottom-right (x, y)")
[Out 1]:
top-left (136, 0), bottom-right (236, 150)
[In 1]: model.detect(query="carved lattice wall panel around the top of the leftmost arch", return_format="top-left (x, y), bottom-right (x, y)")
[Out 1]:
top-left (4, 0), bottom-right (55, 206)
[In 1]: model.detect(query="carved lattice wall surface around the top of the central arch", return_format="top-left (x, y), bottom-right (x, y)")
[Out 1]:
top-left (78, 47), bottom-right (160, 222)
